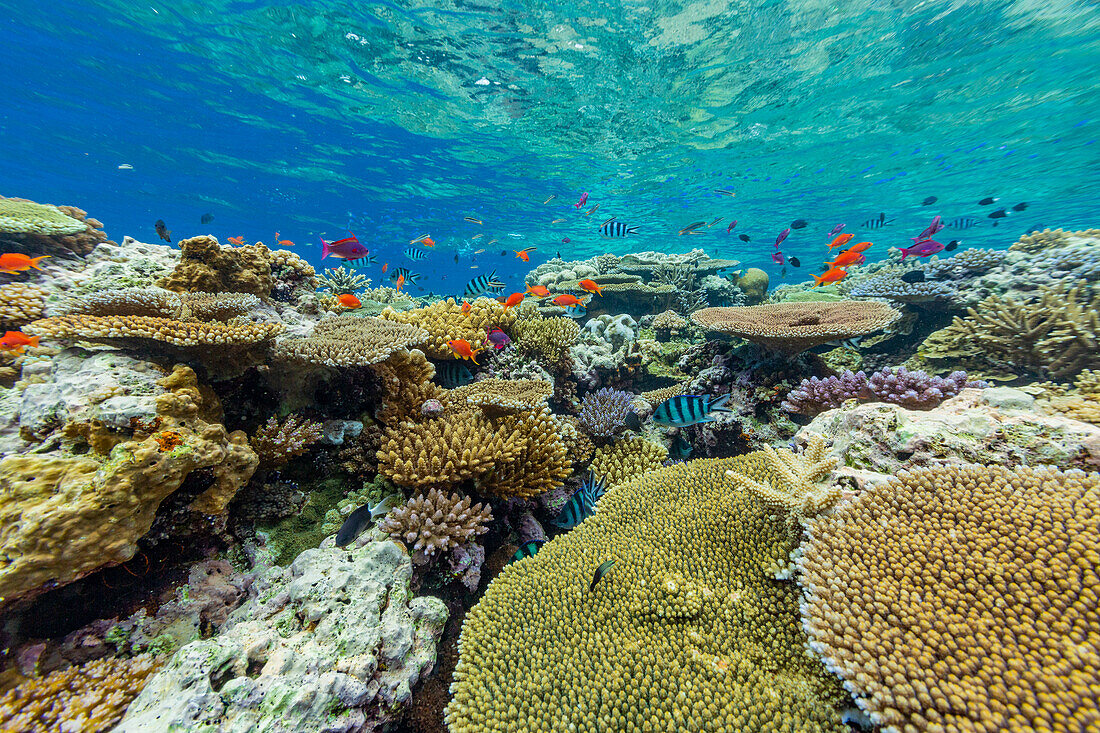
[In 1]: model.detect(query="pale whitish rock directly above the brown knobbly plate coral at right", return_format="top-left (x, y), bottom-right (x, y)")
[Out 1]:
top-left (794, 389), bottom-right (1100, 489)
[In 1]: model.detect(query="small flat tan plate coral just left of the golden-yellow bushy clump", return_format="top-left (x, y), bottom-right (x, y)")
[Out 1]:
top-left (272, 316), bottom-right (428, 367)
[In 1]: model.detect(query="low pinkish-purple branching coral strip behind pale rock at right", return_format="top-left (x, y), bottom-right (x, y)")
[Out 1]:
top-left (781, 367), bottom-right (989, 415)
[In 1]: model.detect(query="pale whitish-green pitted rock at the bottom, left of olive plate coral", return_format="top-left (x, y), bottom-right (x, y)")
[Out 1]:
top-left (114, 539), bottom-right (447, 733)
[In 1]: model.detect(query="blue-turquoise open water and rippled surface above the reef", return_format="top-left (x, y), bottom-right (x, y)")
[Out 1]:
top-left (0, 0), bottom-right (1100, 292)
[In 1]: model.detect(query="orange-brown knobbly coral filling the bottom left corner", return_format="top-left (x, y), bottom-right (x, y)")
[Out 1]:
top-left (0, 655), bottom-right (164, 733)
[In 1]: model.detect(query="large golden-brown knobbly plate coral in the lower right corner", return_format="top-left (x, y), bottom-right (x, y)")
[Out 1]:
top-left (800, 467), bottom-right (1100, 733)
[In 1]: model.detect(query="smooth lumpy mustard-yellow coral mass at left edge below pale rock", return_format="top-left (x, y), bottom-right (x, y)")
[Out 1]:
top-left (0, 365), bottom-right (257, 602)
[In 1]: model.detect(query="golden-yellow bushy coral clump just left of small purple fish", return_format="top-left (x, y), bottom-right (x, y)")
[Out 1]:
top-left (380, 298), bottom-right (516, 359)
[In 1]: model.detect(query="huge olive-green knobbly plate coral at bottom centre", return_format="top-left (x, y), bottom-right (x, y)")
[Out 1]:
top-left (446, 457), bottom-right (848, 733)
